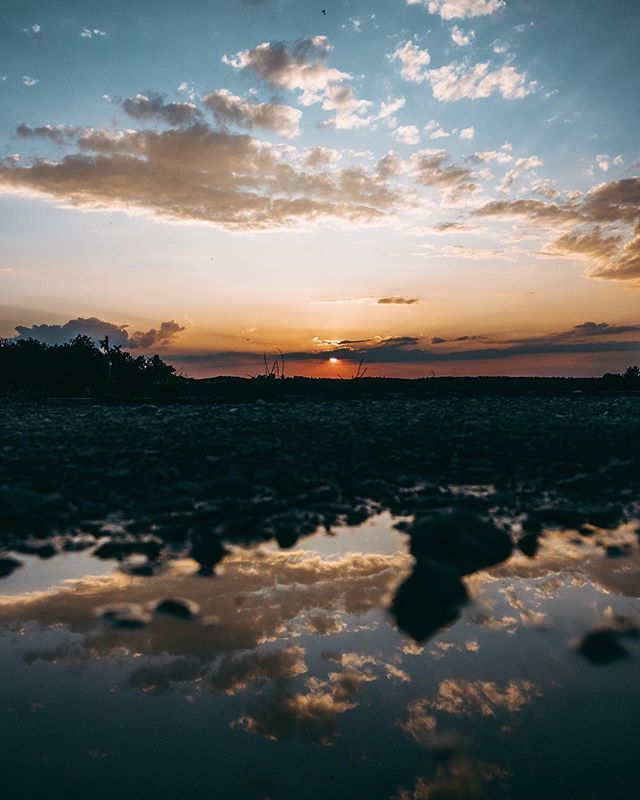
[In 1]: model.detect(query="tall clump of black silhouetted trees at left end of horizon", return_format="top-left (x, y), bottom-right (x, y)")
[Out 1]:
top-left (0, 335), bottom-right (184, 399)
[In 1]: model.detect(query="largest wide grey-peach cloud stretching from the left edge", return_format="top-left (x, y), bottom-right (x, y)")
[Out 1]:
top-left (0, 123), bottom-right (401, 230)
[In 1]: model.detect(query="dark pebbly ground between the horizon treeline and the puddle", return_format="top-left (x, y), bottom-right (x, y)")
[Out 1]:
top-left (0, 395), bottom-right (640, 569)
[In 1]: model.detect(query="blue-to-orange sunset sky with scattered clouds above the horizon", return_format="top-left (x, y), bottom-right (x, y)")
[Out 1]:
top-left (0, 0), bottom-right (640, 377)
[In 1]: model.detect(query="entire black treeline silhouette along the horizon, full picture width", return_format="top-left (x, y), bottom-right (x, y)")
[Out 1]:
top-left (0, 335), bottom-right (640, 403)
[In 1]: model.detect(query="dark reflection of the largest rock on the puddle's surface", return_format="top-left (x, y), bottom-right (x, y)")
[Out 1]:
top-left (391, 563), bottom-right (469, 642)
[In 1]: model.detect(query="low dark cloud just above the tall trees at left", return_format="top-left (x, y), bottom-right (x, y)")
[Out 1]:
top-left (16, 317), bottom-right (186, 349)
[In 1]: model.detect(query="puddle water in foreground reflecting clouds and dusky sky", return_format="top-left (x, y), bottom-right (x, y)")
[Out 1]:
top-left (0, 515), bottom-right (640, 800)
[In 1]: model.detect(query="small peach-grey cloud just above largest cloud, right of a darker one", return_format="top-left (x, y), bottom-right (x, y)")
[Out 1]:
top-left (202, 89), bottom-right (302, 139)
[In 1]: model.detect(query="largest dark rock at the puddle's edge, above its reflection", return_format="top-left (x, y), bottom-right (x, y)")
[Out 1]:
top-left (411, 508), bottom-right (513, 575)
